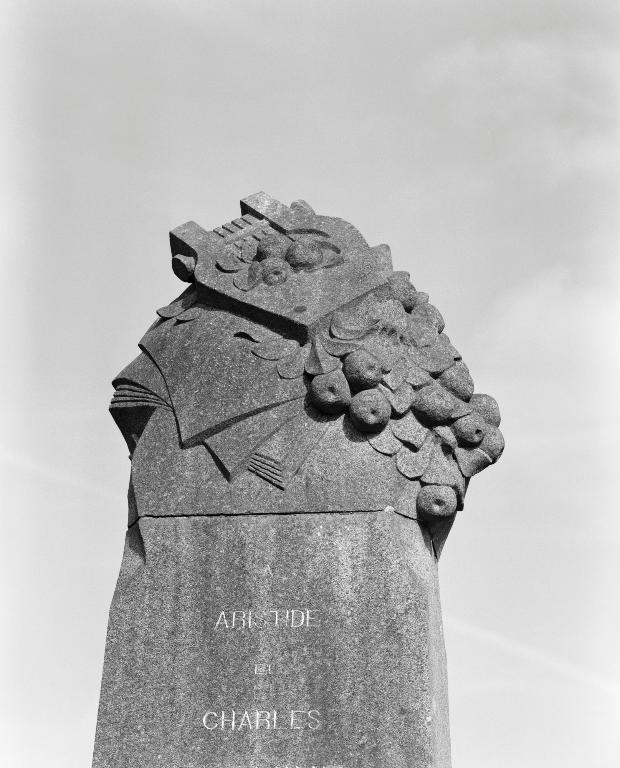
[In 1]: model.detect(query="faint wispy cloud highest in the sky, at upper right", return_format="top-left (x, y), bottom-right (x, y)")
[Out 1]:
top-left (413, 35), bottom-right (620, 186)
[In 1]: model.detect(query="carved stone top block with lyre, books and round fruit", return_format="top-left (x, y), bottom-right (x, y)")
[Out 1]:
top-left (111, 192), bottom-right (504, 554)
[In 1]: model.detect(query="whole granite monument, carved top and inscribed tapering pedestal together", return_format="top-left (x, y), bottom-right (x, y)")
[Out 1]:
top-left (93, 192), bottom-right (504, 768)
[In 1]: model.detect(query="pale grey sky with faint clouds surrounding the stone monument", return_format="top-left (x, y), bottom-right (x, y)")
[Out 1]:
top-left (0, 0), bottom-right (620, 768)
